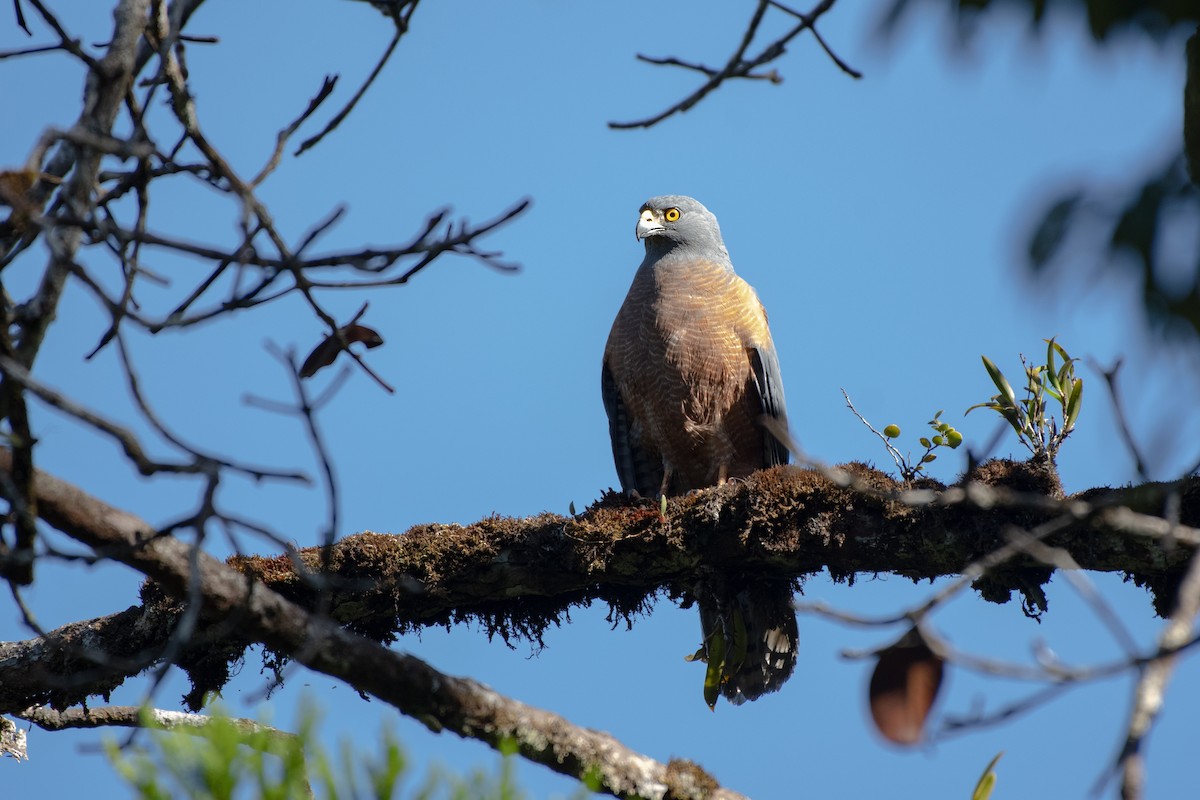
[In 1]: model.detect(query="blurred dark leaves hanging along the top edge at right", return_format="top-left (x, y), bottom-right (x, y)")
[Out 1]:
top-left (880, 0), bottom-right (1200, 42)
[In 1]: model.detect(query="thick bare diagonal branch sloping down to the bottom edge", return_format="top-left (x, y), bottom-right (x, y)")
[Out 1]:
top-left (0, 450), bottom-right (739, 798)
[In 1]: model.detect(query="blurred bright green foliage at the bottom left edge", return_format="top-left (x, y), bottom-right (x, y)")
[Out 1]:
top-left (106, 703), bottom-right (571, 800)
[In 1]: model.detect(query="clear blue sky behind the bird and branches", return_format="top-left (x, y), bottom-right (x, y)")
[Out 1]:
top-left (0, 0), bottom-right (1200, 798)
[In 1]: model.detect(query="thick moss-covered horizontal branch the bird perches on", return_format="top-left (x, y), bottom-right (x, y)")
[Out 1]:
top-left (0, 451), bottom-right (1200, 711)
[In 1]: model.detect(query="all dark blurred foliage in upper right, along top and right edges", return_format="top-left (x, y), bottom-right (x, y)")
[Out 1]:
top-left (880, 0), bottom-right (1200, 347)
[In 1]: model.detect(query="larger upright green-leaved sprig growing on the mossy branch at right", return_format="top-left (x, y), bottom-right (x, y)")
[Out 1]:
top-left (966, 338), bottom-right (1084, 464)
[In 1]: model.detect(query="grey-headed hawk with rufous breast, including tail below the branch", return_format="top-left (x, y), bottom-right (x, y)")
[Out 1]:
top-left (601, 196), bottom-right (797, 705)
